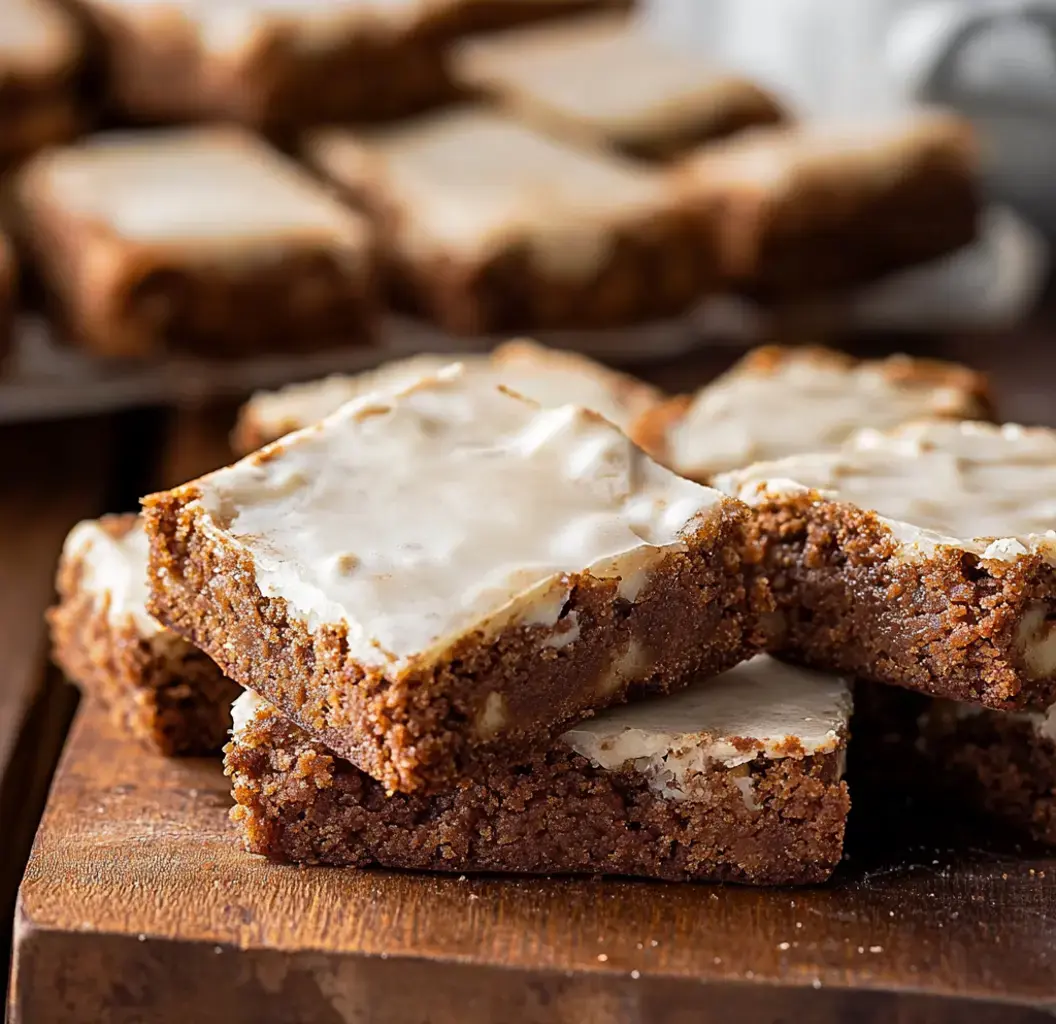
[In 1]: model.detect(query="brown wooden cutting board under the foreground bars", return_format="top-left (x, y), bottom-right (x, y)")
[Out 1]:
top-left (12, 706), bottom-right (1056, 1024)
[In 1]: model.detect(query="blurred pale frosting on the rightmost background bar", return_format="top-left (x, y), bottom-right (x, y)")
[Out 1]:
top-left (683, 111), bottom-right (976, 195)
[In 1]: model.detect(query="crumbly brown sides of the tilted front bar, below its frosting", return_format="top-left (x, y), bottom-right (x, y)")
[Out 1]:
top-left (146, 492), bottom-right (770, 791)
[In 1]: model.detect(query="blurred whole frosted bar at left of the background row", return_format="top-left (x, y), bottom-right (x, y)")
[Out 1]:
top-left (17, 128), bottom-right (377, 357)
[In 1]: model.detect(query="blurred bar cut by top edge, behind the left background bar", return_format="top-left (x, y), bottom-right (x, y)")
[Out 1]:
top-left (70, 0), bottom-right (457, 135)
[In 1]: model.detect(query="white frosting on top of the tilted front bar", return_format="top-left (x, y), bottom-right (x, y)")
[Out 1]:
top-left (188, 366), bottom-right (727, 672)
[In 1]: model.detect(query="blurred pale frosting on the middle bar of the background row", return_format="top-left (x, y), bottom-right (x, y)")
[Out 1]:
top-left (309, 108), bottom-right (673, 278)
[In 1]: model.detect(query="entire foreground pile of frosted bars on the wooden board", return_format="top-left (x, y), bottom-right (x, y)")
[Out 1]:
top-left (53, 342), bottom-right (1056, 884)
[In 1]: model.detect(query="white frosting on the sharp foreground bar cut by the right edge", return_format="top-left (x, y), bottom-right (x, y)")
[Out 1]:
top-left (716, 421), bottom-right (1056, 565)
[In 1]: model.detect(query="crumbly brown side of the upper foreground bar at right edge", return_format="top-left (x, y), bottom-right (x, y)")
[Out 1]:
top-left (749, 492), bottom-right (1056, 709)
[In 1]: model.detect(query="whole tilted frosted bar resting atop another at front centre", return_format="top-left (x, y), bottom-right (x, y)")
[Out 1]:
top-left (145, 365), bottom-right (766, 792)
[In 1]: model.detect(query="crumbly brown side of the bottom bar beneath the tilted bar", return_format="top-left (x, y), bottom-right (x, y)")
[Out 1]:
top-left (226, 696), bottom-right (849, 885)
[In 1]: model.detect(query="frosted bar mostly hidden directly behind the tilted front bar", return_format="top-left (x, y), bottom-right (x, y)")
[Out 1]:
top-left (233, 341), bottom-right (662, 455)
